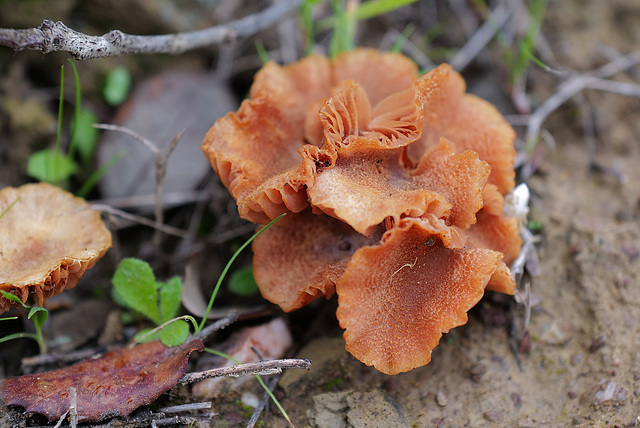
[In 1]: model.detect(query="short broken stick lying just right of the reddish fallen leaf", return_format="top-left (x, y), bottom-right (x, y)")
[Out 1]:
top-left (178, 358), bottom-right (311, 385)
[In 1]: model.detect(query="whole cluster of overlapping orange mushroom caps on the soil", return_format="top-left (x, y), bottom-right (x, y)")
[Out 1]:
top-left (202, 49), bottom-right (522, 374)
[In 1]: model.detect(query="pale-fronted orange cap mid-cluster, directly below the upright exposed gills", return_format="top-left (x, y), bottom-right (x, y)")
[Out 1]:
top-left (307, 138), bottom-right (490, 235)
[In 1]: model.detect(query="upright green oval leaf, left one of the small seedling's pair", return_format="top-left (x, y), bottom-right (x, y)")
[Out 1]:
top-left (112, 258), bottom-right (161, 324)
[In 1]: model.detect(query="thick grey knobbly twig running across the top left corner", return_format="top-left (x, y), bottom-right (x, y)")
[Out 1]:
top-left (0, 0), bottom-right (302, 60)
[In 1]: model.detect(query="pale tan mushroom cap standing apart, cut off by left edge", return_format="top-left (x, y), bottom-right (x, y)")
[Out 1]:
top-left (0, 183), bottom-right (111, 310)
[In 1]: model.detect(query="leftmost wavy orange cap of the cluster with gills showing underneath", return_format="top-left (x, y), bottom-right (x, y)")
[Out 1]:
top-left (202, 55), bottom-right (330, 223)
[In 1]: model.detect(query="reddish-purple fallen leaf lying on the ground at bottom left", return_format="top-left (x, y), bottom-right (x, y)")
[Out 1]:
top-left (0, 340), bottom-right (204, 421)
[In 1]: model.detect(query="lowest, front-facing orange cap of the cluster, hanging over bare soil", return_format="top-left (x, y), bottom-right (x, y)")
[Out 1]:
top-left (336, 219), bottom-right (502, 374)
